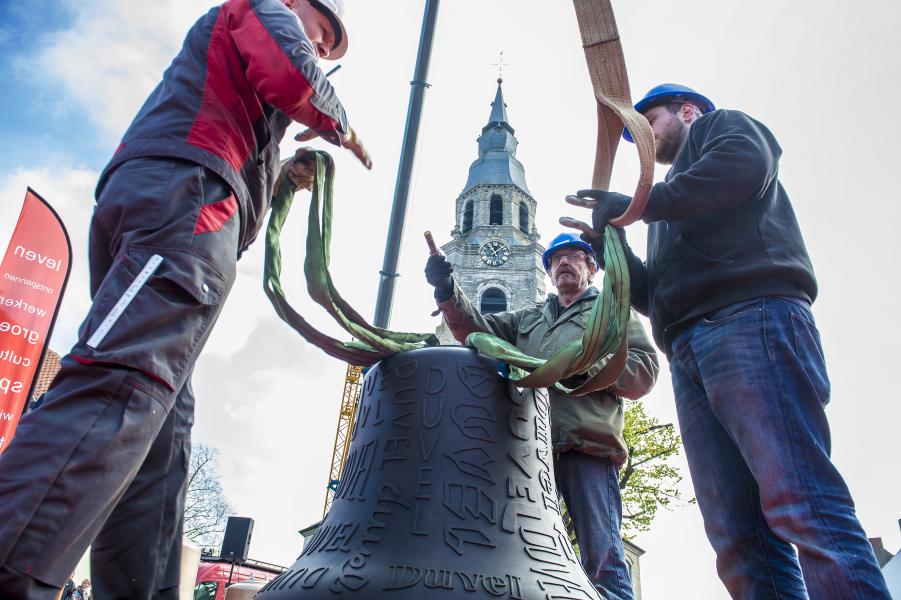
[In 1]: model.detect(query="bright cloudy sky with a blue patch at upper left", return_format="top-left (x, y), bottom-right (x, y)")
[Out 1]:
top-left (0, 0), bottom-right (901, 599)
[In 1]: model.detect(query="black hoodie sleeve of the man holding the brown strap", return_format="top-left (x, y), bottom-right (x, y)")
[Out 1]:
top-left (642, 110), bottom-right (781, 223)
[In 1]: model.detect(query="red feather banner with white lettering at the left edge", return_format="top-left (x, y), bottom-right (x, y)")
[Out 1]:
top-left (0, 188), bottom-right (72, 453)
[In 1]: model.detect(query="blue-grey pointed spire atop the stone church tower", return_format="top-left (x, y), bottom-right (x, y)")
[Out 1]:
top-left (463, 77), bottom-right (532, 196)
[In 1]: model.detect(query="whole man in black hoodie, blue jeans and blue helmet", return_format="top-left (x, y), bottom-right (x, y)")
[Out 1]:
top-left (567, 84), bottom-right (889, 600)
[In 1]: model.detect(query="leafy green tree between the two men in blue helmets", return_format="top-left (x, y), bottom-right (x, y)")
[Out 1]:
top-left (619, 402), bottom-right (694, 539)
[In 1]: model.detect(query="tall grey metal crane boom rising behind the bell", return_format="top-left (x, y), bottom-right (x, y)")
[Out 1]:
top-left (373, 0), bottom-right (439, 327)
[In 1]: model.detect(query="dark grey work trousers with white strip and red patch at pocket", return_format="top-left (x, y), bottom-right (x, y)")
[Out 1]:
top-left (0, 159), bottom-right (240, 600)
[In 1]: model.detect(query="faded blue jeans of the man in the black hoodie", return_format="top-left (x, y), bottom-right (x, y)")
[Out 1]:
top-left (670, 297), bottom-right (890, 600)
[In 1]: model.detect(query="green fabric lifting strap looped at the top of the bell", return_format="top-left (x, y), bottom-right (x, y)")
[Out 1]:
top-left (263, 151), bottom-right (629, 394)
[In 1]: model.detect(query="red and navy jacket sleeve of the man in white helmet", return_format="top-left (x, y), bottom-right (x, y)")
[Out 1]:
top-left (223, 0), bottom-right (348, 144)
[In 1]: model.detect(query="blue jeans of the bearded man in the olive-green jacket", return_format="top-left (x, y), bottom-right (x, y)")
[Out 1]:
top-left (554, 450), bottom-right (633, 600)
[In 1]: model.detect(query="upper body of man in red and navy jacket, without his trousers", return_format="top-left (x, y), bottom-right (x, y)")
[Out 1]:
top-left (104, 0), bottom-right (369, 249)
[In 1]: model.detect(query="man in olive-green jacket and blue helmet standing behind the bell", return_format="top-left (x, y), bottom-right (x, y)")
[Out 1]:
top-left (425, 233), bottom-right (659, 600)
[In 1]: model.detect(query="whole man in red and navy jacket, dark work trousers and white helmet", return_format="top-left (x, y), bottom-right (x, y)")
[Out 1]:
top-left (0, 0), bottom-right (370, 600)
